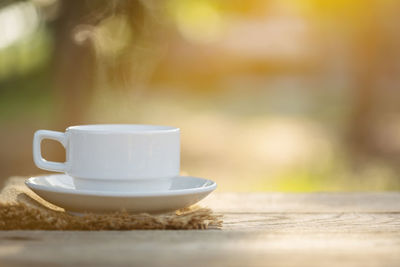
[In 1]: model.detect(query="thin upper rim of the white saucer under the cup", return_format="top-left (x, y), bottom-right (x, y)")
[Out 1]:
top-left (25, 174), bottom-right (217, 197)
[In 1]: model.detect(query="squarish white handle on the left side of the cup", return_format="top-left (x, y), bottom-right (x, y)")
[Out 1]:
top-left (33, 130), bottom-right (66, 172)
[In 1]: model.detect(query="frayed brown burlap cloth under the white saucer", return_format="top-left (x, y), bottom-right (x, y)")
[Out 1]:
top-left (0, 177), bottom-right (222, 230)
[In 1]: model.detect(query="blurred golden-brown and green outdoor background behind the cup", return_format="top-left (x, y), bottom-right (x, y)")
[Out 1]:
top-left (0, 0), bottom-right (400, 192)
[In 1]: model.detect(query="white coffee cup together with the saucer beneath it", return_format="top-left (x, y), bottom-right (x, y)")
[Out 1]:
top-left (26, 124), bottom-right (216, 215)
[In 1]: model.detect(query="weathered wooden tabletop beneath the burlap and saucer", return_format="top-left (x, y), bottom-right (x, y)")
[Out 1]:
top-left (0, 193), bottom-right (400, 267)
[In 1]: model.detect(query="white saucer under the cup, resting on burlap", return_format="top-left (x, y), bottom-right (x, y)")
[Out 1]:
top-left (25, 174), bottom-right (217, 213)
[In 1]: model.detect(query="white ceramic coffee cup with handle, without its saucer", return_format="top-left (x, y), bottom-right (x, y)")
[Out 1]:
top-left (33, 124), bottom-right (180, 190)
